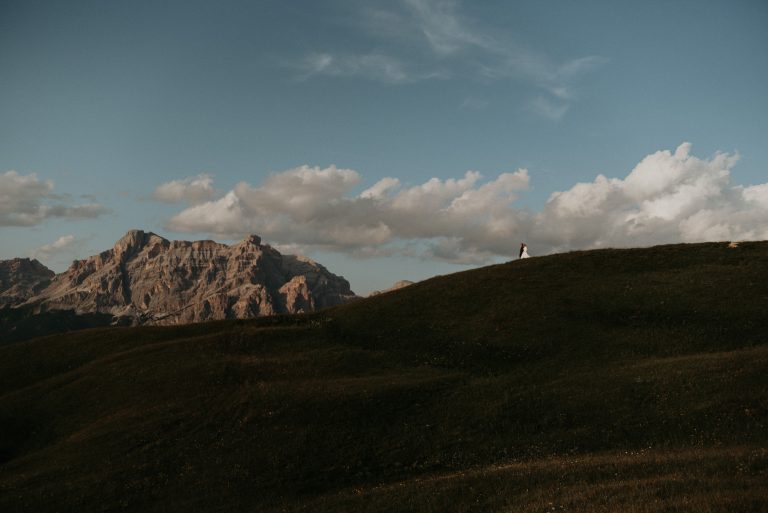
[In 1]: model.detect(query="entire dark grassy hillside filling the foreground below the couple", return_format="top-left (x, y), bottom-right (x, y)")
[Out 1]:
top-left (0, 242), bottom-right (768, 513)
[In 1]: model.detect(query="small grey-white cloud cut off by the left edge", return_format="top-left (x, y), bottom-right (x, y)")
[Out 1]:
top-left (0, 171), bottom-right (109, 226)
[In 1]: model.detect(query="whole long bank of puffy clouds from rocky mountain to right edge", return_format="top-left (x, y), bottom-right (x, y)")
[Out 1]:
top-left (162, 143), bottom-right (768, 264)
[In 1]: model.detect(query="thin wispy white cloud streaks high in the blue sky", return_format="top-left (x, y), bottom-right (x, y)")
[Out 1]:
top-left (294, 0), bottom-right (608, 121)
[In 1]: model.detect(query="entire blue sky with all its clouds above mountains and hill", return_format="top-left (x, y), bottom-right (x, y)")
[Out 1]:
top-left (0, 0), bottom-right (768, 294)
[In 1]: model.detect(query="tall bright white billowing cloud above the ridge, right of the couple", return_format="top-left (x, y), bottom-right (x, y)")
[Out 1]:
top-left (528, 143), bottom-right (768, 251)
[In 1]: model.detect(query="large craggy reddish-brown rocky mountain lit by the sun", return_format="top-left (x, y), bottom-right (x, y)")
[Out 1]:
top-left (21, 230), bottom-right (356, 324)
